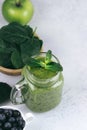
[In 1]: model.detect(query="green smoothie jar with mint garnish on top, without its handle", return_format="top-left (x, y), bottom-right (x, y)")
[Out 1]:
top-left (10, 51), bottom-right (64, 112)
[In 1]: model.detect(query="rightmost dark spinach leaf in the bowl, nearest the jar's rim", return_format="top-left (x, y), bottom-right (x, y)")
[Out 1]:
top-left (20, 38), bottom-right (42, 64)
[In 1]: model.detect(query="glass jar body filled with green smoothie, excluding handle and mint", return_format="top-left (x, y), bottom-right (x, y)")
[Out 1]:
top-left (23, 50), bottom-right (63, 112)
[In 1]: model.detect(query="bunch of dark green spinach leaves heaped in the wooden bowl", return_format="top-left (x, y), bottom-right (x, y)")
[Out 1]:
top-left (0, 22), bottom-right (43, 69)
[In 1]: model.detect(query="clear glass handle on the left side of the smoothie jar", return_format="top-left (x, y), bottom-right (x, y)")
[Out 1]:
top-left (10, 79), bottom-right (26, 104)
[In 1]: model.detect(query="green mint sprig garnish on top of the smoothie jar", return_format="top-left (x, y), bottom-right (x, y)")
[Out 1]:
top-left (27, 50), bottom-right (63, 71)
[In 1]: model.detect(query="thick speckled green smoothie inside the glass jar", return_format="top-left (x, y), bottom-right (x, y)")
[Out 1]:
top-left (22, 67), bottom-right (63, 112)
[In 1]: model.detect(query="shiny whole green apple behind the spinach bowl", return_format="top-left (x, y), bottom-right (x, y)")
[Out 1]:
top-left (2, 0), bottom-right (34, 25)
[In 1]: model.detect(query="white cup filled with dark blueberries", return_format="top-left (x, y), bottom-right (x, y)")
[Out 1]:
top-left (0, 106), bottom-right (33, 130)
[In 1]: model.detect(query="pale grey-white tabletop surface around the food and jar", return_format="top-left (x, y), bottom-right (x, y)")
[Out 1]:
top-left (0, 0), bottom-right (87, 130)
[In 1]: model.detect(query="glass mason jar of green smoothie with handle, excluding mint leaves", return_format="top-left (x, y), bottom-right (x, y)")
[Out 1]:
top-left (11, 52), bottom-right (64, 112)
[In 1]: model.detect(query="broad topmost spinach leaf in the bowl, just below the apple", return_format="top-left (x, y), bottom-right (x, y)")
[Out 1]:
top-left (0, 22), bottom-right (29, 44)
